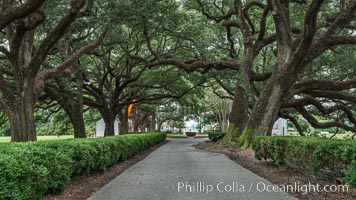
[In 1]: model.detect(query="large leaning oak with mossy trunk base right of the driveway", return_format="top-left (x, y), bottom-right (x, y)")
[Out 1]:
top-left (188, 0), bottom-right (356, 147)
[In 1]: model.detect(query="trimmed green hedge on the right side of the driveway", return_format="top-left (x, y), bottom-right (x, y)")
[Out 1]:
top-left (253, 136), bottom-right (356, 187)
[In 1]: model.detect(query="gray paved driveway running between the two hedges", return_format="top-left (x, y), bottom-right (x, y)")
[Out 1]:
top-left (89, 139), bottom-right (295, 200)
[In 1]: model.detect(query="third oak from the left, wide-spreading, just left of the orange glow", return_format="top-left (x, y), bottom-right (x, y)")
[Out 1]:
top-left (77, 2), bottom-right (209, 136)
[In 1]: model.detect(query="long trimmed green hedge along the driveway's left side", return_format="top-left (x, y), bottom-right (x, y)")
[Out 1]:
top-left (0, 133), bottom-right (166, 199)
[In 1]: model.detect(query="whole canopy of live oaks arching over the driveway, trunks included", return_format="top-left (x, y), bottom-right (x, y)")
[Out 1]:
top-left (0, 0), bottom-right (356, 147)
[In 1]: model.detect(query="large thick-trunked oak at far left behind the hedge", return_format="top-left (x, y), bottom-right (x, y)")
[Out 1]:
top-left (0, 0), bottom-right (102, 141)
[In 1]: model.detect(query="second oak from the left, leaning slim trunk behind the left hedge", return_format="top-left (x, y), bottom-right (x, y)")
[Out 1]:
top-left (38, 1), bottom-right (120, 138)
